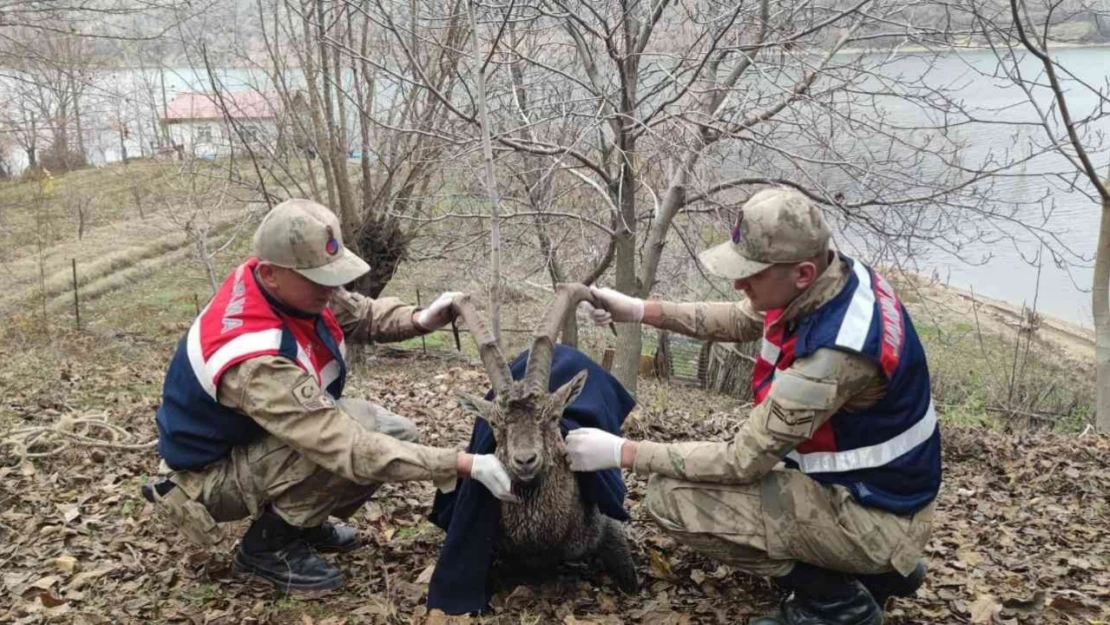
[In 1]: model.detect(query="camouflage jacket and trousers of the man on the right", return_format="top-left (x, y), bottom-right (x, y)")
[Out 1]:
top-left (633, 196), bottom-right (935, 577)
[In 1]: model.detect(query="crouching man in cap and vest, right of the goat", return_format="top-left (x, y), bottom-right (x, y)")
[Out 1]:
top-left (567, 189), bottom-right (941, 625)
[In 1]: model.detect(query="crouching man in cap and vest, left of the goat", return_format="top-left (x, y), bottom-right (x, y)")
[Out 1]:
top-left (143, 200), bottom-right (513, 591)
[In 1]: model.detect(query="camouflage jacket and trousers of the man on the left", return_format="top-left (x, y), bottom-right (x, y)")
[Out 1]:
top-left (161, 290), bottom-right (457, 537)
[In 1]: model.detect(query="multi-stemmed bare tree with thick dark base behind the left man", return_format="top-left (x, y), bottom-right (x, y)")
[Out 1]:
top-left (179, 0), bottom-right (467, 296)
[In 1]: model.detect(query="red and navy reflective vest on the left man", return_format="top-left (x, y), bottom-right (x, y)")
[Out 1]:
top-left (155, 258), bottom-right (346, 471)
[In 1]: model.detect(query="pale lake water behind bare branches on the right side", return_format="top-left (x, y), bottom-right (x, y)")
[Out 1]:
top-left (843, 48), bottom-right (1110, 327)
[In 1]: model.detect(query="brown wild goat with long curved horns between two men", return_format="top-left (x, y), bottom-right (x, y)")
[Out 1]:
top-left (444, 284), bottom-right (639, 593)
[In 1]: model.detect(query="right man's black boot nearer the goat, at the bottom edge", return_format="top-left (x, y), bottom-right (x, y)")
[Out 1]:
top-left (748, 562), bottom-right (882, 625)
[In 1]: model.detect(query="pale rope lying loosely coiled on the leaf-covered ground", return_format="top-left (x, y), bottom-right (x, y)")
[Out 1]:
top-left (0, 413), bottom-right (158, 460)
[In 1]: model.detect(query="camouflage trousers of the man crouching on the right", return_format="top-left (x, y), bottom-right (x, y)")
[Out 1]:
top-left (646, 470), bottom-right (936, 577)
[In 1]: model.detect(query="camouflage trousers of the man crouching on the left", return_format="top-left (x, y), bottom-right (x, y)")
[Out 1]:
top-left (160, 397), bottom-right (420, 527)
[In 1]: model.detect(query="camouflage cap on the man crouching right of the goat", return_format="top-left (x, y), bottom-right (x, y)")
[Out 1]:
top-left (698, 189), bottom-right (830, 280)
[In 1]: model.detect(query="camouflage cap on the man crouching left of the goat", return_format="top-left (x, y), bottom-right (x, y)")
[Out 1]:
top-left (254, 200), bottom-right (370, 286)
